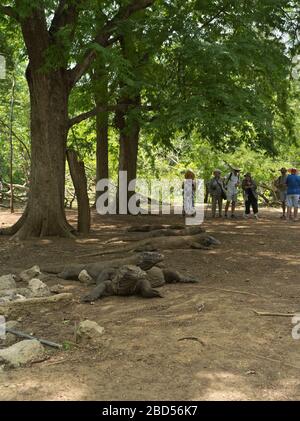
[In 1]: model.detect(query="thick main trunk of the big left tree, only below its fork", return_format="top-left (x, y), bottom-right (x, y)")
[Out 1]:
top-left (2, 65), bottom-right (72, 239)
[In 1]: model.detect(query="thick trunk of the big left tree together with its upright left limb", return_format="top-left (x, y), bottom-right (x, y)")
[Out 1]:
top-left (0, 9), bottom-right (72, 239)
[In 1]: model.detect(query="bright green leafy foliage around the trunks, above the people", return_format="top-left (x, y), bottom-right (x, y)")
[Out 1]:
top-left (0, 0), bottom-right (300, 202)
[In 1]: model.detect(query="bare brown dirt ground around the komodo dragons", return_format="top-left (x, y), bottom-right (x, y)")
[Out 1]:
top-left (0, 209), bottom-right (300, 400)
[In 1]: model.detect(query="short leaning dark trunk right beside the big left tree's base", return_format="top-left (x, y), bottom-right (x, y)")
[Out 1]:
top-left (67, 149), bottom-right (91, 234)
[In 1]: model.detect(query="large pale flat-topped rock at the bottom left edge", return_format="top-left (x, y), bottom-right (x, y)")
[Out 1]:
top-left (0, 339), bottom-right (45, 368)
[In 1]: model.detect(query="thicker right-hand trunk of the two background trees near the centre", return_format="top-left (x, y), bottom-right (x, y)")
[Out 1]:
top-left (115, 96), bottom-right (141, 211)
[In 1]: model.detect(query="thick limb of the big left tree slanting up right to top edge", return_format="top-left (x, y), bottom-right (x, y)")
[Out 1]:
top-left (69, 0), bottom-right (156, 86)
